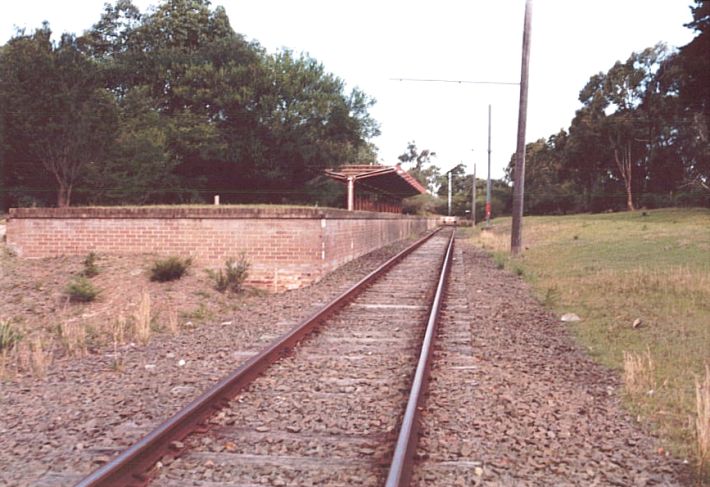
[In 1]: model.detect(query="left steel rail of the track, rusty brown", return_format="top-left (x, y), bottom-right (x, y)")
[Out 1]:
top-left (76, 228), bottom-right (440, 487)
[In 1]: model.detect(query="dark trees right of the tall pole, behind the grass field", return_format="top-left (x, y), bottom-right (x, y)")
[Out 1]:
top-left (507, 0), bottom-right (710, 214)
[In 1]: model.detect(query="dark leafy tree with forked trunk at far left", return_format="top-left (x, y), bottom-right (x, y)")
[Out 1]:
top-left (0, 23), bottom-right (117, 206)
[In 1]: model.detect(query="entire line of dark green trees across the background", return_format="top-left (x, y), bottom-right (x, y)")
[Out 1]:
top-left (0, 0), bottom-right (710, 215)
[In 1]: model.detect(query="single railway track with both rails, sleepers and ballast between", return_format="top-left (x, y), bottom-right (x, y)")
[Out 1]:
top-left (78, 232), bottom-right (453, 487)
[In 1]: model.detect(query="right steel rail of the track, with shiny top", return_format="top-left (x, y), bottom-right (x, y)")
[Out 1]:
top-left (385, 228), bottom-right (456, 487)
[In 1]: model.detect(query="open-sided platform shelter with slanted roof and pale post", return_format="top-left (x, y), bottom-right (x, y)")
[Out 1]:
top-left (325, 164), bottom-right (427, 213)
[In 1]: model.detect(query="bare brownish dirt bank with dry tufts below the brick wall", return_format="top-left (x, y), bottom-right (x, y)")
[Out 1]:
top-left (0, 250), bottom-right (252, 368)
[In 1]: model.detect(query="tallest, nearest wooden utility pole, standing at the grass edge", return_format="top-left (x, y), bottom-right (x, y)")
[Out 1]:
top-left (510, 0), bottom-right (532, 255)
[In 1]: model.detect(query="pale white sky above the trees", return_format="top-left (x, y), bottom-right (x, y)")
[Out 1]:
top-left (0, 0), bottom-right (693, 177)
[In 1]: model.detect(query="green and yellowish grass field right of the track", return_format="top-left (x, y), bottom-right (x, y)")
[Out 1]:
top-left (474, 209), bottom-right (710, 478)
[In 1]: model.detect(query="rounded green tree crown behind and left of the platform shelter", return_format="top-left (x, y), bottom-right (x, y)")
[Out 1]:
top-left (253, 51), bottom-right (378, 194)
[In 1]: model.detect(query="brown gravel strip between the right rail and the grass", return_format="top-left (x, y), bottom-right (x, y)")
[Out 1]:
top-left (415, 242), bottom-right (690, 486)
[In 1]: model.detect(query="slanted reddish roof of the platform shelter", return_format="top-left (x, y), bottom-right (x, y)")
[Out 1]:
top-left (325, 164), bottom-right (427, 199)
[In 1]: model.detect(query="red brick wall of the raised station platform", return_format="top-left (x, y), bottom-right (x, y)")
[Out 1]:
top-left (7, 206), bottom-right (439, 291)
